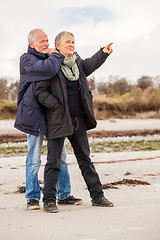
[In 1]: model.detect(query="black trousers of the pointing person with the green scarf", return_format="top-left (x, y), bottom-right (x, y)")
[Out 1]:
top-left (43, 117), bottom-right (103, 204)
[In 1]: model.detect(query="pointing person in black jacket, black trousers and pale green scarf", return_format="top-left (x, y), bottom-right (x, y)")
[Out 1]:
top-left (35, 32), bottom-right (113, 212)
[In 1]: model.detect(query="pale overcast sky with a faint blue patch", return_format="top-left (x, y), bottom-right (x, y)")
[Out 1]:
top-left (0, 0), bottom-right (160, 82)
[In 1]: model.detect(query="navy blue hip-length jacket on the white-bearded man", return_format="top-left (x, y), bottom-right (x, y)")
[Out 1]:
top-left (14, 46), bottom-right (64, 136)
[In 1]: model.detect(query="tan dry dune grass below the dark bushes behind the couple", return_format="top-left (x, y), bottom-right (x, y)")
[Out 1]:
top-left (0, 87), bottom-right (160, 120)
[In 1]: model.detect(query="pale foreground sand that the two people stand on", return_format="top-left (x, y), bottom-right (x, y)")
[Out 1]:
top-left (0, 120), bottom-right (160, 240)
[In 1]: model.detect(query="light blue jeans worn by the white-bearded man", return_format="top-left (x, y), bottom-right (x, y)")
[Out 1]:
top-left (25, 133), bottom-right (71, 200)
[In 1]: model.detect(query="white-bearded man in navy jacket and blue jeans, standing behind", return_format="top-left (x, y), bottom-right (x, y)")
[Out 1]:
top-left (14, 29), bottom-right (82, 210)
